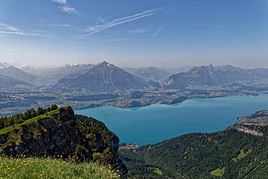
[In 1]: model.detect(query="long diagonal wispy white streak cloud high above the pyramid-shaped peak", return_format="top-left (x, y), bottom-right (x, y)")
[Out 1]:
top-left (86, 8), bottom-right (162, 35)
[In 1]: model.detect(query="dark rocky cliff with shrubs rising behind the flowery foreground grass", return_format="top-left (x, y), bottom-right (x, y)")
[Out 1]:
top-left (0, 107), bottom-right (127, 175)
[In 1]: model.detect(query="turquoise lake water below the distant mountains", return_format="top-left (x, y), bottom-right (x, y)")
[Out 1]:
top-left (75, 94), bottom-right (268, 144)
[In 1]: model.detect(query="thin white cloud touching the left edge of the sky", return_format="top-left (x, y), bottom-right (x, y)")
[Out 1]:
top-left (0, 23), bottom-right (42, 36)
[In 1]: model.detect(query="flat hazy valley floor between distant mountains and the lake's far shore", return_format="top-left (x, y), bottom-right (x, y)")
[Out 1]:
top-left (0, 88), bottom-right (265, 116)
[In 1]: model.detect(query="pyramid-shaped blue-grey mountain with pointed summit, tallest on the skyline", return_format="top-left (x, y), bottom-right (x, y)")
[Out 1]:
top-left (54, 62), bottom-right (153, 92)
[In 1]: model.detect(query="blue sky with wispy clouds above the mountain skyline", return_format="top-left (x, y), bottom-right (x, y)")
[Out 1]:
top-left (0, 0), bottom-right (268, 67)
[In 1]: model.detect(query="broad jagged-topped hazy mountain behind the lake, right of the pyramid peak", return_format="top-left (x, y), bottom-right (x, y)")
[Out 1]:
top-left (164, 65), bottom-right (268, 89)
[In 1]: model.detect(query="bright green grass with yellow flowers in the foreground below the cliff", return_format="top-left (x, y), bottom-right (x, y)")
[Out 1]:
top-left (0, 157), bottom-right (120, 179)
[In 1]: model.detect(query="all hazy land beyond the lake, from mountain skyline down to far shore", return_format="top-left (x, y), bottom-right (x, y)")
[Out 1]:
top-left (0, 62), bottom-right (268, 117)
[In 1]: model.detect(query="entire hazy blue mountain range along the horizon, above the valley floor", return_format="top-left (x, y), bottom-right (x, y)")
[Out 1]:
top-left (0, 62), bottom-right (268, 92)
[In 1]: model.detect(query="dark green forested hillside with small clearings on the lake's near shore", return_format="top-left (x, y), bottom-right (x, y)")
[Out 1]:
top-left (120, 111), bottom-right (268, 179)
